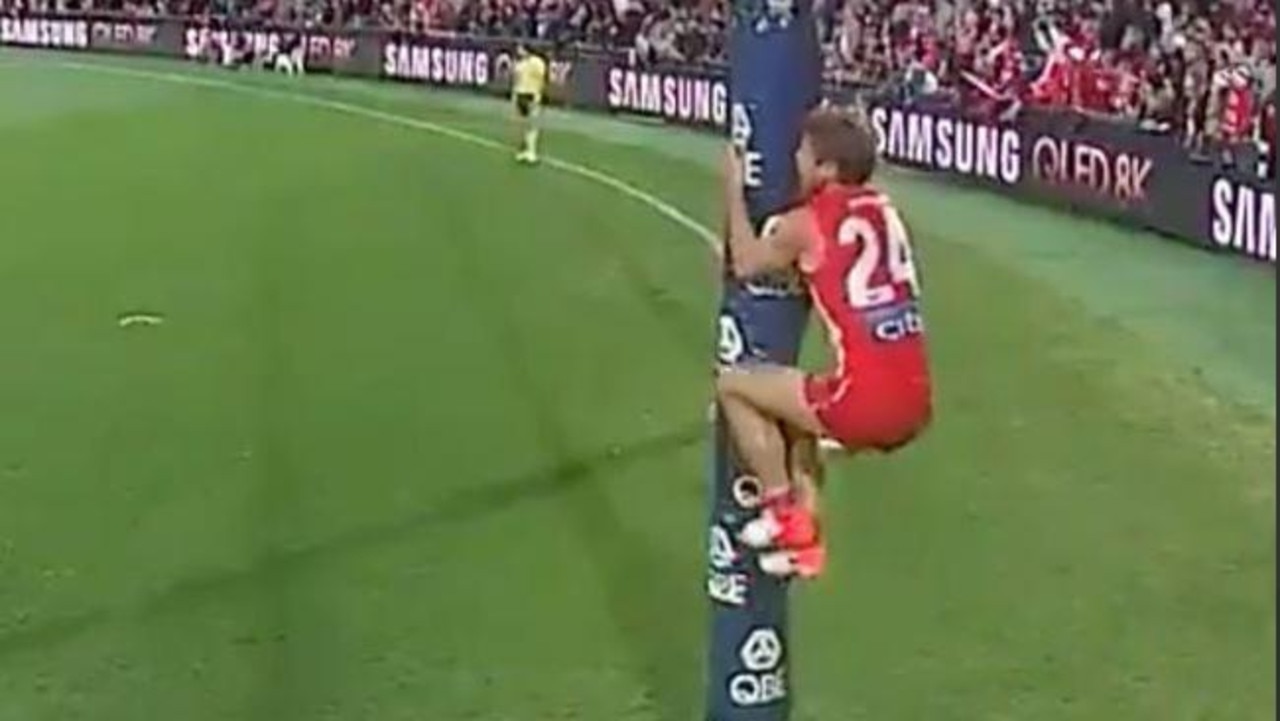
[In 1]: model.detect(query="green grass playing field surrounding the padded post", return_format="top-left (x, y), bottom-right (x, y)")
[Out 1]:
top-left (0, 51), bottom-right (1276, 721)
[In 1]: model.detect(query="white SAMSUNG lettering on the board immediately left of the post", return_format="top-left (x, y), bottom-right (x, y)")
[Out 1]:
top-left (605, 68), bottom-right (728, 127)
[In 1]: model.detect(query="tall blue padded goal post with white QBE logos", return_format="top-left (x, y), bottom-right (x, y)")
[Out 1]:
top-left (705, 0), bottom-right (822, 721)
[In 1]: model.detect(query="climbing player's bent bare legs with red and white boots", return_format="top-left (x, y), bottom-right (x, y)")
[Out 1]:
top-left (717, 366), bottom-right (826, 576)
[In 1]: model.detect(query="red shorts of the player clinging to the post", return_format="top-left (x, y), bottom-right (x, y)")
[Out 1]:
top-left (804, 374), bottom-right (933, 451)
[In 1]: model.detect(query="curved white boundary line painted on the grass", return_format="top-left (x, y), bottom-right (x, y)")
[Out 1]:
top-left (22, 60), bottom-right (719, 250)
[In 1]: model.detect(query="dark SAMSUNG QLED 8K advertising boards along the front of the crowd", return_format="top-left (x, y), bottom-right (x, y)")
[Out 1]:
top-left (0, 10), bottom-right (1276, 264)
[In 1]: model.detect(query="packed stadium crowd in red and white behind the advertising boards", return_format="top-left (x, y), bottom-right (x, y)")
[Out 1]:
top-left (0, 0), bottom-right (1276, 150)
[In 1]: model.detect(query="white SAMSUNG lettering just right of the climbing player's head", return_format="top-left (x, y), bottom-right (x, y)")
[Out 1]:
top-left (870, 108), bottom-right (1023, 186)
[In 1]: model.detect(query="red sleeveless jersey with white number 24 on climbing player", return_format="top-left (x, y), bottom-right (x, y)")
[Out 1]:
top-left (800, 184), bottom-right (928, 387)
